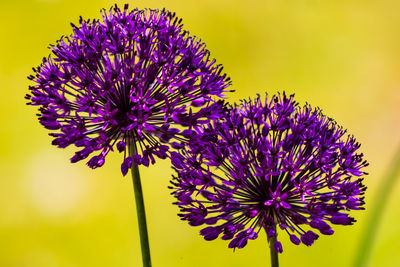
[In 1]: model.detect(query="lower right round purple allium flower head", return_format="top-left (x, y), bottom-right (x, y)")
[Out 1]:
top-left (171, 93), bottom-right (368, 252)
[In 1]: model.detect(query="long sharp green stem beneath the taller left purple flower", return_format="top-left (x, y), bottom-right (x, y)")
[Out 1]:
top-left (130, 144), bottom-right (151, 267)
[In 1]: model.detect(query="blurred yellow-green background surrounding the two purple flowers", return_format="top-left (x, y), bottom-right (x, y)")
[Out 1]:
top-left (0, 0), bottom-right (400, 267)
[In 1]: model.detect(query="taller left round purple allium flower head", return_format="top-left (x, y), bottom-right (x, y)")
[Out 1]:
top-left (26, 5), bottom-right (230, 175)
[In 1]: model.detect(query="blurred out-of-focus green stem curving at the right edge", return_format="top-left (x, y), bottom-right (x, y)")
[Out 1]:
top-left (353, 148), bottom-right (400, 267)
